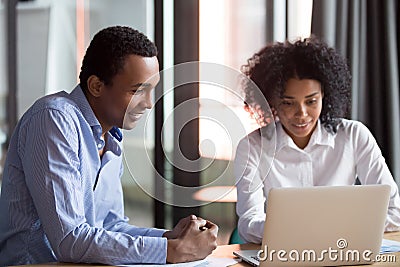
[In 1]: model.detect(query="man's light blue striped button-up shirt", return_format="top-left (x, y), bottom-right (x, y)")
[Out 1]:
top-left (0, 86), bottom-right (167, 265)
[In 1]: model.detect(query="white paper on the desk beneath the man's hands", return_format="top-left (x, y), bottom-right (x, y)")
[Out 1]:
top-left (119, 257), bottom-right (239, 267)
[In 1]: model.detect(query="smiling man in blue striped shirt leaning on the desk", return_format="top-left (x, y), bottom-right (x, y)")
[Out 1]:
top-left (0, 26), bottom-right (218, 265)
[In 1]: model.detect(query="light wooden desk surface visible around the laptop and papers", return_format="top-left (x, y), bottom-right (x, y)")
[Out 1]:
top-left (10, 232), bottom-right (400, 267)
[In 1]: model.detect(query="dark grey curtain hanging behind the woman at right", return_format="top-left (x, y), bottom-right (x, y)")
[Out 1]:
top-left (311, 0), bottom-right (400, 184)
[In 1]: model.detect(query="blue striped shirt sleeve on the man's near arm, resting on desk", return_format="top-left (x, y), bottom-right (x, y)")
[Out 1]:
top-left (19, 109), bottom-right (167, 265)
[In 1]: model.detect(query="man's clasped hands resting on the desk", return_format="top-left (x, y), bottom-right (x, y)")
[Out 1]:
top-left (164, 215), bottom-right (218, 263)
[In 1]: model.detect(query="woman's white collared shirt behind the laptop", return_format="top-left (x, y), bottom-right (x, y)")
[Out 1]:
top-left (234, 119), bottom-right (400, 243)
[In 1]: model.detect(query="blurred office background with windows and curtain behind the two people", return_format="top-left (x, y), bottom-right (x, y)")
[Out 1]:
top-left (0, 0), bottom-right (400, 244)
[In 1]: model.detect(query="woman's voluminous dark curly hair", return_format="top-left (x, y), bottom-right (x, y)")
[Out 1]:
top-left (242, 36), bottom-right (351, 132)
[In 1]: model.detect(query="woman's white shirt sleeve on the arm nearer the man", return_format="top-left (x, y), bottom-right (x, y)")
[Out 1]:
top-left (234, 136), bottom-right (265, 243)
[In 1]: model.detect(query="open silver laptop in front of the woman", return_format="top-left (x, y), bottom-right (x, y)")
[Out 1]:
top-left (234, 185), bottom-right (390, 267)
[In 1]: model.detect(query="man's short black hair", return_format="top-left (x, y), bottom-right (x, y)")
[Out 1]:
top-left (79, 26), bottom-right (157, 91)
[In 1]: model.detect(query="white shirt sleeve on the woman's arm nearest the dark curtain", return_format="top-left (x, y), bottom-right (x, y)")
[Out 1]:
top-left (350, 122), bottom-right (400, 231)
